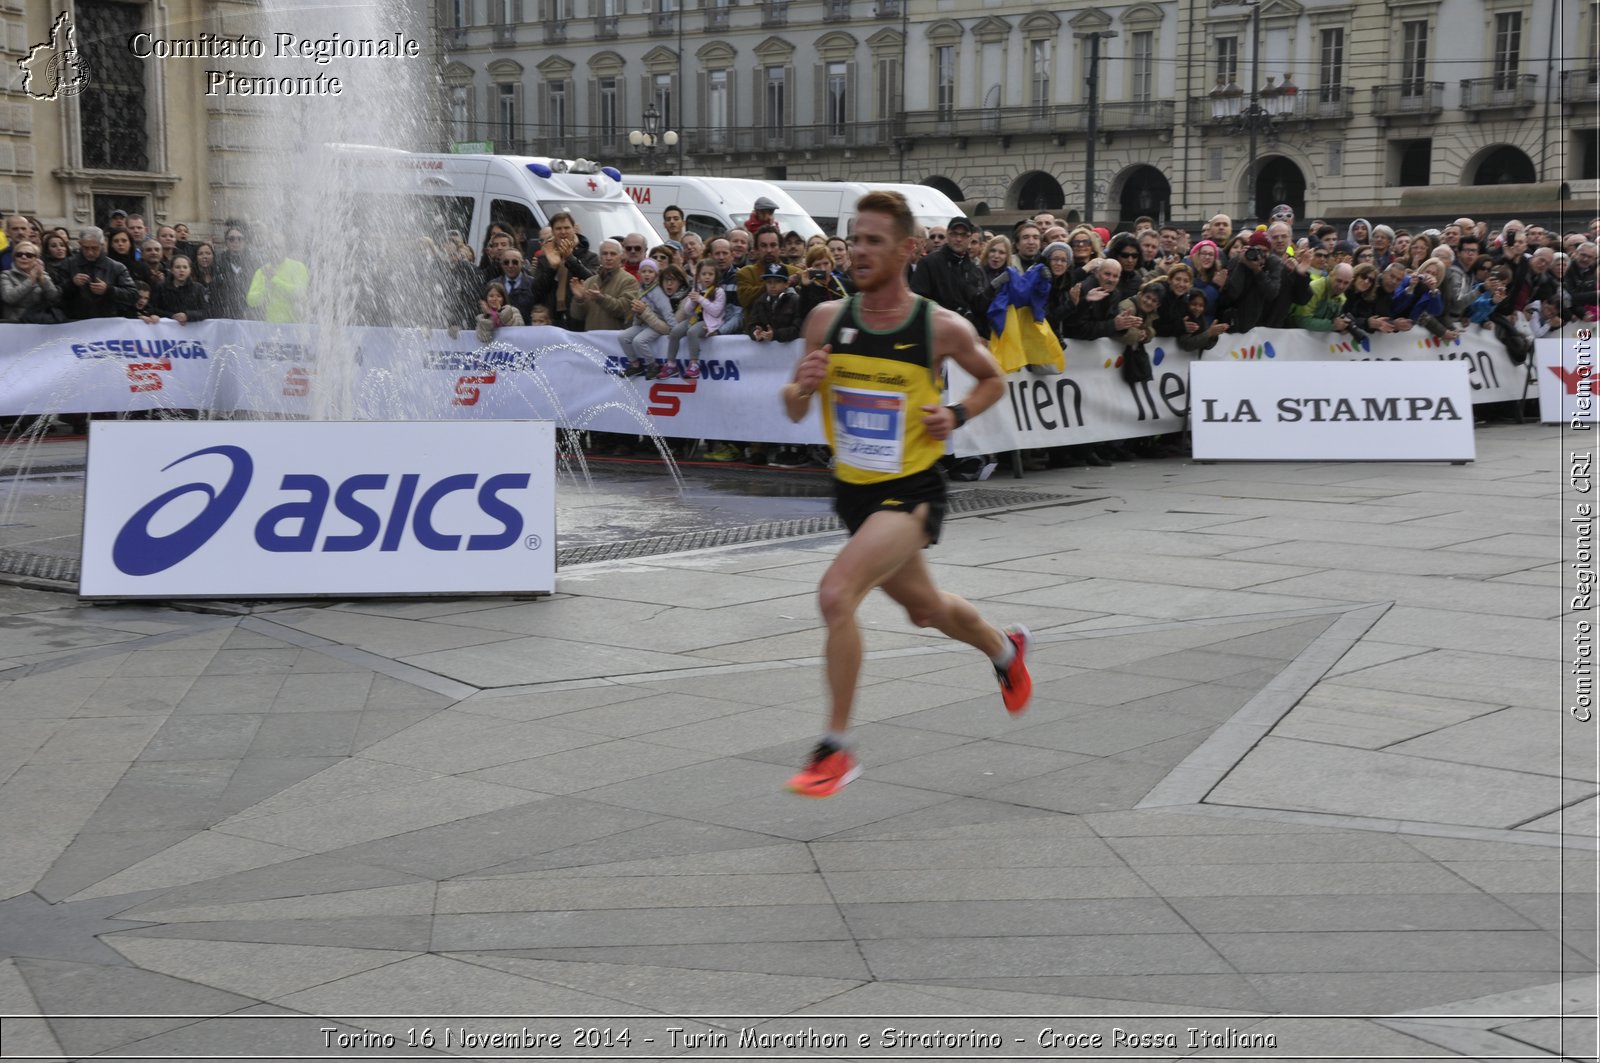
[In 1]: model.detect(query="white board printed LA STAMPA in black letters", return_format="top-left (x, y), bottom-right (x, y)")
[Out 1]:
top-left (1189, 362), bottom-right (1477, 461)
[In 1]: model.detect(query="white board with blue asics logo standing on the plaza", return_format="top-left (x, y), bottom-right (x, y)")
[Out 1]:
top-left (78, 421), bottom-right (555, 599)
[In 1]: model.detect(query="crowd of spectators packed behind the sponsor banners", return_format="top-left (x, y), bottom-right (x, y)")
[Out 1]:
top-left (0, 202), bottom-right (1600, 464)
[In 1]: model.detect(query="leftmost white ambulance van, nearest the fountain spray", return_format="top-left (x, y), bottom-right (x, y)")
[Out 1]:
top-left (338, 144), bottom-right (662, 251)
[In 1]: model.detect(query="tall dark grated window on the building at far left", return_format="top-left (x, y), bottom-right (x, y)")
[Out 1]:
top-left (75, 0), bottom-right (150, 170)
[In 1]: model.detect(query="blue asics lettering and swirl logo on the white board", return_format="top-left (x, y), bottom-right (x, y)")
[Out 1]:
top-left (112, 445), bottom-right (533, 576)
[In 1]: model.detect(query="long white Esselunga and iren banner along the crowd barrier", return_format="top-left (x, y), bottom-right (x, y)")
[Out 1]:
top-left (0, 319), bottom-right (1534, 455)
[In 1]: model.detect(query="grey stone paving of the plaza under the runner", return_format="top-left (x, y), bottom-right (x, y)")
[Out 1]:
top-left (0, 426), bottom-right (1600, 1058)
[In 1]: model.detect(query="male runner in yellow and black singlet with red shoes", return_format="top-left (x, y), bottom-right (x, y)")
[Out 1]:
top-left (784, 192), bottom-right (1034, 797)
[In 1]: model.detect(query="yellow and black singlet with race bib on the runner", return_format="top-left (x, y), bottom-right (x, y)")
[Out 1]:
top-left (822, 295), bottom-right (944, 483)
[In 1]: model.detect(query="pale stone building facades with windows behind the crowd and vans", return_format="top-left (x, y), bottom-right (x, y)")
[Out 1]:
top-left (0, 0), bottom-right (1600, 231)
